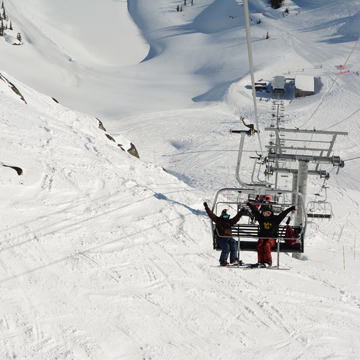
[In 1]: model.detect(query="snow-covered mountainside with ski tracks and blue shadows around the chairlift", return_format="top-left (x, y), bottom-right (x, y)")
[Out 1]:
top-left (0, 0), bottom-right (360, 359)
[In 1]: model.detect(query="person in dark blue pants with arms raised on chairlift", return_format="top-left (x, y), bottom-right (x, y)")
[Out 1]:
top-left (204, 202), bottom-right (243, 266)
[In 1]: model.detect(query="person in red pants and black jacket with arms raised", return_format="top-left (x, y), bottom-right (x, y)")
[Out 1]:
top-left (245, 201), bottom-right (299, 266)
